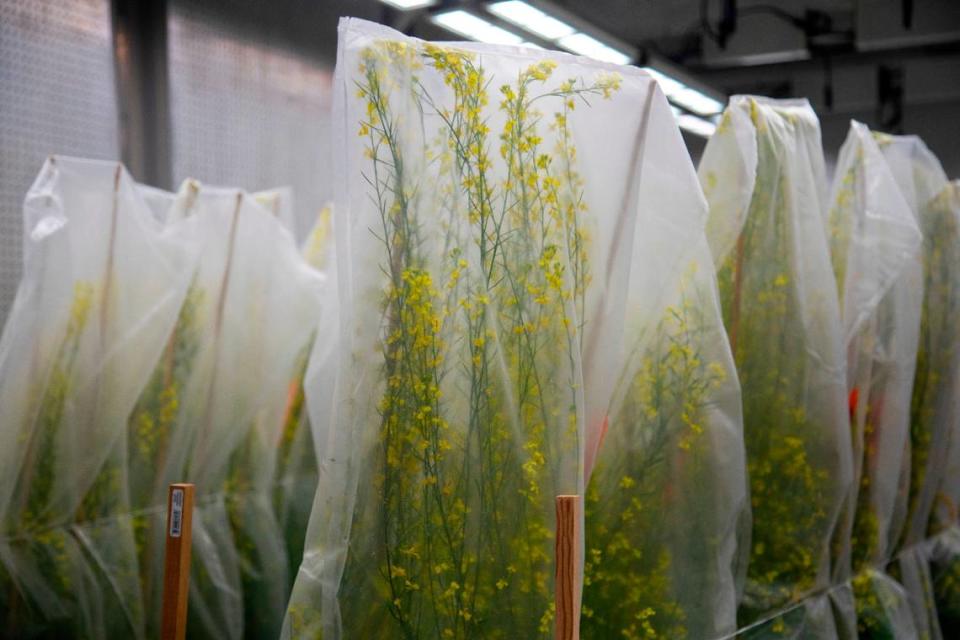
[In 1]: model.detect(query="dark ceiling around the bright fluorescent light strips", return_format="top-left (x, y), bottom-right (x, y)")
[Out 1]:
top-left (179, 0), bottom-right (960, 174)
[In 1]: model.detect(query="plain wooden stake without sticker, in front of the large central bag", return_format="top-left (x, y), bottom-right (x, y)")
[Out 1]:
top-left (554, 495), bottom-right (581, 640)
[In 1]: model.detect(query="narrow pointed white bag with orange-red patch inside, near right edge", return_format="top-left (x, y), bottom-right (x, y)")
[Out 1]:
top-left (827, 122), bottom-right (923, 638)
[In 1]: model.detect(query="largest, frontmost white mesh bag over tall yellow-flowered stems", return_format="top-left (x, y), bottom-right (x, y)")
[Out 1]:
top-left (285, 20), bottom-right (668, 638)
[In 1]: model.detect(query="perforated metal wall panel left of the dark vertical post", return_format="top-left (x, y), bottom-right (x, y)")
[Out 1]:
top-left (0, 0), bottom-right (119, 325)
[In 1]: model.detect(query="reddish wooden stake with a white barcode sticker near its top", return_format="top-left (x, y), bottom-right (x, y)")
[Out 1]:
top-left (160, 484), bottom-right (193, 640)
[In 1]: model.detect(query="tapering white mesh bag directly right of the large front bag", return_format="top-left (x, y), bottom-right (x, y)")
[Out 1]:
top-left (581, 87), bottom-right (749, 640)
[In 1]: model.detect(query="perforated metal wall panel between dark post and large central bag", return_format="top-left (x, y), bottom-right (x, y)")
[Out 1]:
top-left (168, 0), bottom-right (335, 237)
